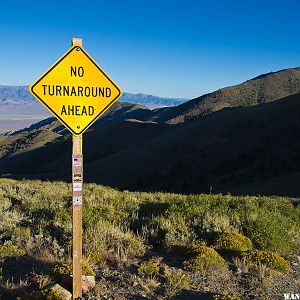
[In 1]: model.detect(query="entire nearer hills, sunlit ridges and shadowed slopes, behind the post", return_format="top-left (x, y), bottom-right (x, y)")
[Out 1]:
top-left (0, 68), bottom-right (300, 196)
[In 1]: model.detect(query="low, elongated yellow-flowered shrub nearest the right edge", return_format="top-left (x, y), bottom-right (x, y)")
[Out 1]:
top-left (242, 250), bottom-right (291, 273)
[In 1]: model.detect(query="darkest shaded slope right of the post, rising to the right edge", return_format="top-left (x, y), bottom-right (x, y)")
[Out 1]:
top-left (82, 94), bottom-right (300, 196)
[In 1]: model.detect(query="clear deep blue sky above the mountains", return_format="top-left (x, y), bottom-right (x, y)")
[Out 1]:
top-left (0, 0), bottom-right (300, 98)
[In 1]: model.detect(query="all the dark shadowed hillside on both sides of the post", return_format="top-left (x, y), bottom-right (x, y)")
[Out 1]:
top-left (0, 94), bottom-right (300, 196)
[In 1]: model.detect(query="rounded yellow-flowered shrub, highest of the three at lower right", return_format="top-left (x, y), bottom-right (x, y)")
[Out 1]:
top-left (214, 232), bottom-right (252, 251)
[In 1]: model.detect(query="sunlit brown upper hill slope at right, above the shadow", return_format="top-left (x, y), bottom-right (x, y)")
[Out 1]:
top-left (155, 68), bottom-right (300, 124)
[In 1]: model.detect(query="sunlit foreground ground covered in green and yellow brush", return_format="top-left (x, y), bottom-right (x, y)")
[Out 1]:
top-left (0, 179), bottom-right (300, 300)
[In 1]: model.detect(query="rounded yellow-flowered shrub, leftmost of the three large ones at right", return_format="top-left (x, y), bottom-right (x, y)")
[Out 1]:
top-left (184, 245), bottom-right (226, 273)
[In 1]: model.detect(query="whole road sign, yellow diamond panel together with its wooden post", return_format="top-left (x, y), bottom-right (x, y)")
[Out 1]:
top-left (29, 38), bottom-right (122, 300)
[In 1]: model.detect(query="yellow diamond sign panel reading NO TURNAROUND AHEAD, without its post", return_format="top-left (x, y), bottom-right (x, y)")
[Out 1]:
top-left (29, 45), bottom-right (122, 135)
